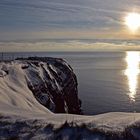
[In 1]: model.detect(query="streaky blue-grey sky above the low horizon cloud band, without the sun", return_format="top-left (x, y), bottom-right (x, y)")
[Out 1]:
top-left (0, 0), bottom-right (140, 49)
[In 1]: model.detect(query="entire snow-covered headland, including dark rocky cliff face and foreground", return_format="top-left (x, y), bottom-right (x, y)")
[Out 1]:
top-left (0, 58), bottom-right (140, 140)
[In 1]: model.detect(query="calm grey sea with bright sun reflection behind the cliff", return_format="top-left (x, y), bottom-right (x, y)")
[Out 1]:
top-left (1, 52), bottom-right (140, 114)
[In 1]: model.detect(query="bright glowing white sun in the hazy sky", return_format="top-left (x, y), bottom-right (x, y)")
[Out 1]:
top-left (125, 12), bottom-right (140, 33)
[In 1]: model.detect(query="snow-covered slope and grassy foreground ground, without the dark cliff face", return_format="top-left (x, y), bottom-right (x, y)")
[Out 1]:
top-left (0, 58), bottom-right (140, 140)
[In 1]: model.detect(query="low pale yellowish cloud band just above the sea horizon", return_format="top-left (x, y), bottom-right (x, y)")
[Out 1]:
top-left (0, 40), bottom-right (140, 52)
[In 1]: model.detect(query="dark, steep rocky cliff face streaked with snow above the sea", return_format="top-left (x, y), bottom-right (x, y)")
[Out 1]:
top-left (18, 57), bottom-right (81, 114)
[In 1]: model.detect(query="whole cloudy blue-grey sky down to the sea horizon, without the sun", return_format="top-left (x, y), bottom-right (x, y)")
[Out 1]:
top-left (0, 0), bottom-right (140, 51)
